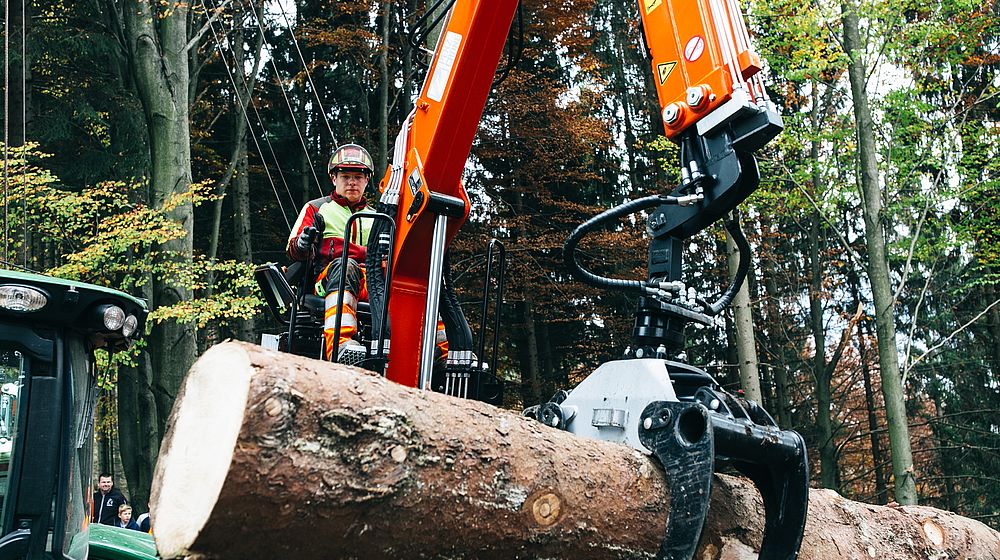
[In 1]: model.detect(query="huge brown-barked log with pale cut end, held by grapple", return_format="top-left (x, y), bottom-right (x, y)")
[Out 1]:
top-left (151, 343), bottom-right (1000, 560)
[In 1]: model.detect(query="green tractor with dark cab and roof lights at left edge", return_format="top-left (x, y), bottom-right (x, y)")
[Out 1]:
top-left (0, 270), bottom-right (155, 560)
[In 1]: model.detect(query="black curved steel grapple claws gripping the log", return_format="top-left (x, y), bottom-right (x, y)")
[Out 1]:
top-left (639, 394), bottom-right (809, 560)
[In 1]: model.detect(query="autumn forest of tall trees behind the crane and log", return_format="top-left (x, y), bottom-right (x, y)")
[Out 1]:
top-left (2, 0), bottom-right (1000, 527)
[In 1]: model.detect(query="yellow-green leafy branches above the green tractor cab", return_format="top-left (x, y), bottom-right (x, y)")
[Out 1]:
top-left (0, 145), bottom-right (262, 334)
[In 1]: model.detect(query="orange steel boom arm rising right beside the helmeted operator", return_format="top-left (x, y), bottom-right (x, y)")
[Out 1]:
top-left (386, 0), bottom-right (518, 387)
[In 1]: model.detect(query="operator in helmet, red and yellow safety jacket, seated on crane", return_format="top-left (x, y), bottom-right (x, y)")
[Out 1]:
top-left (286, 144), bottom-right (448, 365)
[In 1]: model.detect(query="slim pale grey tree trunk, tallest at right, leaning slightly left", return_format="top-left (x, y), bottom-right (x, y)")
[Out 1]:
top-left (842, 3), bottom-right (917, 505)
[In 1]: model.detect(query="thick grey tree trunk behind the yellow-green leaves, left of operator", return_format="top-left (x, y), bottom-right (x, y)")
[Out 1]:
top-left (124, 0), bottom-right (196, 442)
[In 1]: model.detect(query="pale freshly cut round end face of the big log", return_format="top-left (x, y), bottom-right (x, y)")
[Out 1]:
top-left (150, 343), bottom-right (254, 558)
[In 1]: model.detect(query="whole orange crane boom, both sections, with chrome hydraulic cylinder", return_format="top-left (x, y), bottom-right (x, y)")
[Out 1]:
top-left (369, 0), bottom-right (780, 388)
